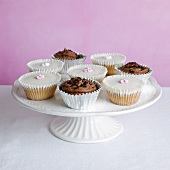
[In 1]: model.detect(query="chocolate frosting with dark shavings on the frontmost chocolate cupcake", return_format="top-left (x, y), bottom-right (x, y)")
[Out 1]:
top-left (60, 77), bottom-right (97, 95)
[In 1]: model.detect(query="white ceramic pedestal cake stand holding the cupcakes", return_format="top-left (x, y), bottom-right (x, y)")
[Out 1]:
top-left (12, 77), bottom-right (162, 143)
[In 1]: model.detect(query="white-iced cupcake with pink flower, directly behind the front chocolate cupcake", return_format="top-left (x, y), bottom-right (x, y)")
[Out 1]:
top-left (67, 64), bottom-right (107, 83)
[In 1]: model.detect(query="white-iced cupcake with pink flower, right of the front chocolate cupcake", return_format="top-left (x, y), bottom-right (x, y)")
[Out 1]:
top-left (103, 75), bottom-right (144, 106)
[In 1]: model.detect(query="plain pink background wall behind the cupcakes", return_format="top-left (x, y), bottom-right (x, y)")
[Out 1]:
top-left (0, 0), bottom-right (170, 86)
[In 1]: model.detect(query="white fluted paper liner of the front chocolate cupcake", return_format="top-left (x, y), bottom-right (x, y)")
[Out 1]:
top-left (58, 81), bottom-right (101, 110)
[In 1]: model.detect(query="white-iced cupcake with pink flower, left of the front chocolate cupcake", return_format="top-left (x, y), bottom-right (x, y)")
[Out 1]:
top-left (18, 71), bottom-right (61, 100)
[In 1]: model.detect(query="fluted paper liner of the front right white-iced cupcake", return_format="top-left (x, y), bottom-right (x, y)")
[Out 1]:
top-left (103, 75), bottom-right (144, 106)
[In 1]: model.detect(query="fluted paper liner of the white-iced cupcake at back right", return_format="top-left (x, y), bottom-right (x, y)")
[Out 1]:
top-left (90, 53), bottom-right (126, 75)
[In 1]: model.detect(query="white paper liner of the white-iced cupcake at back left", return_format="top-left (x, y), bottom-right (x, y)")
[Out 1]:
top-left (27, 59), bottom-right (64, 73)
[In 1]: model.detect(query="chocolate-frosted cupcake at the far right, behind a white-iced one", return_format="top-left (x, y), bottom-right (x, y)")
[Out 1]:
top-left (117, 62), bottom-right (152, 83)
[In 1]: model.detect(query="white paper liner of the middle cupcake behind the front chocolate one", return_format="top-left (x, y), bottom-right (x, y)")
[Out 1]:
top-left (67, 64), bottom-right (107, 81)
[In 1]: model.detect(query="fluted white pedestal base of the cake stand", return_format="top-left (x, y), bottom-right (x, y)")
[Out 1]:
top-left (50, 116), bottom-right (123, 143)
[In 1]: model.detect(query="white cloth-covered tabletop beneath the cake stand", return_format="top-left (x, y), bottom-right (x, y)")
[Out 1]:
top-left (0, 86), bottom-right (170, 170)
